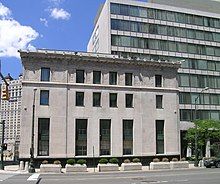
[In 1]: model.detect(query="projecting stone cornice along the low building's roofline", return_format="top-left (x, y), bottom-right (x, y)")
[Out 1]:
top-left (19, 49), bottom-right (181, 69)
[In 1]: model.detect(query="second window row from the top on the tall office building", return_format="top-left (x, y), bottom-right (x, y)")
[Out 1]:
top-left (111, 19), bottom-right (220, 42)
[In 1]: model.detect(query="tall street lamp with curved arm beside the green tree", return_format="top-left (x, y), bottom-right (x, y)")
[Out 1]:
top-left (194, 87), bottom-right (209, 167)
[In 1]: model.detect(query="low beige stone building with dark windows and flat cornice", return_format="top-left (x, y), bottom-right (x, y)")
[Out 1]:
top-left (20, 50), bottom-right (180, 162)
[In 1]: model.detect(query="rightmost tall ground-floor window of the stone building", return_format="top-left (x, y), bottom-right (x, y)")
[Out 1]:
top-left (156, 120), bottom-right (164, 154)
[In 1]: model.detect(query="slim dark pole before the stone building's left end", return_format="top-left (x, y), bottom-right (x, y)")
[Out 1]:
top-left (28, 88), bottom-right (37, 173)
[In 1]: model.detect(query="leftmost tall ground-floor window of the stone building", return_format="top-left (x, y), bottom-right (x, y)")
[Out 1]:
top-left (37, 118), bottom-right (50, 156)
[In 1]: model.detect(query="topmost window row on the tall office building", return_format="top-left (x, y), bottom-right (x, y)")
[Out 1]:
top-left (111, 3), bottom-right (220, 28)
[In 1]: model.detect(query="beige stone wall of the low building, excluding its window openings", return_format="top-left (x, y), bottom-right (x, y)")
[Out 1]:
top-left (20, 50), bottom-right (180, 159)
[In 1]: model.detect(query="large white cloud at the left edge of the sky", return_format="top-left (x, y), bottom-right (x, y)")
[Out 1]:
top-left (0, 4), bottom-right (39, 58)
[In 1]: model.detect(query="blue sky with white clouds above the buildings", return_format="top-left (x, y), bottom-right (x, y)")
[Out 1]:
top-left (0, 0), bottom-right (105, 78)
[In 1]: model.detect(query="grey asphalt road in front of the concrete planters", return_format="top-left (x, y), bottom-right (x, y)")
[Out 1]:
top-left (0, 168), bottom-right (220, 184)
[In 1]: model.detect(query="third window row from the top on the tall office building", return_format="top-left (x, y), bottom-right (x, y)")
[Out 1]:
top-left (111, 35), bottom-right (220, 56)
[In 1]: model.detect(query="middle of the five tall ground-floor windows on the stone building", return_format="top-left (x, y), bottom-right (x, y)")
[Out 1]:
top-left (100, 119), bottom-right (111, 155)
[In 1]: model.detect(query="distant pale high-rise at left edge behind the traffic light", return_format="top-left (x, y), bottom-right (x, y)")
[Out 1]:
top-left (0, 75), bottom-right (22, 158)
